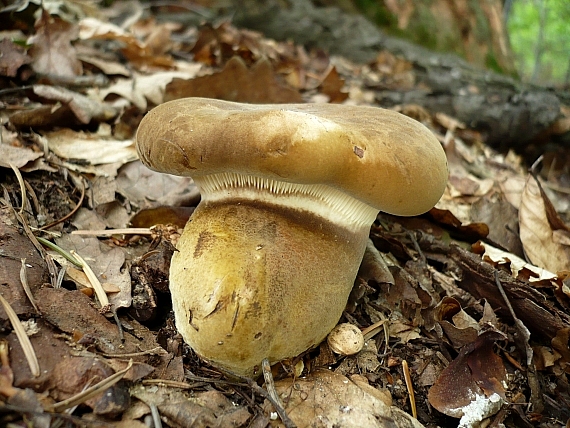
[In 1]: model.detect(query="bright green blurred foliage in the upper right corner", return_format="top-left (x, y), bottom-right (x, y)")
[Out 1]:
top-left (508, 0), bottom-right (570, 84)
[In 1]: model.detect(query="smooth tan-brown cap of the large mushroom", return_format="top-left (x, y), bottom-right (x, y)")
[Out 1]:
top-left (136, 98), bottom-right (448, 215)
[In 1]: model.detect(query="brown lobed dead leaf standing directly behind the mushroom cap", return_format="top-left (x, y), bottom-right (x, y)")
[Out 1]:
top-left (165, 56), bottom-right (303, 103)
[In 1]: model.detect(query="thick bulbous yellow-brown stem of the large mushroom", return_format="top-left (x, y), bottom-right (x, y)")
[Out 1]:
top-left (170, 179), bottom-right (376, 376)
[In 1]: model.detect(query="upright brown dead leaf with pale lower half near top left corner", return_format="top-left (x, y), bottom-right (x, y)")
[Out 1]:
top-left (28, 9), bottom-right (83, 77)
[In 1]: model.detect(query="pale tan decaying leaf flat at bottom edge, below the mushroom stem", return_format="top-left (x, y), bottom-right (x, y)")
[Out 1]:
top-left (265, 370), bottom-right (423, 428)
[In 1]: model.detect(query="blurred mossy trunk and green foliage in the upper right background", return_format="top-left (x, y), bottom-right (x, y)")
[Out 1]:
top-left (342, 0), bottom-right (570, 88)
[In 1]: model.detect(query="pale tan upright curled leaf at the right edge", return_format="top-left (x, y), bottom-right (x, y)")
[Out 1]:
top-left (519, 175), bottom-right (570, 272)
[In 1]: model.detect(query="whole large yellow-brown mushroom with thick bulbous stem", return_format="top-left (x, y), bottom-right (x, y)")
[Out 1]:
top-left (136, 98), bottom-right (448, 376)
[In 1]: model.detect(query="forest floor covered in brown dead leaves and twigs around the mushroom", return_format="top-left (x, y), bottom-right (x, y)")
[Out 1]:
top-left (0, 1), bottom-right (570, 427)
